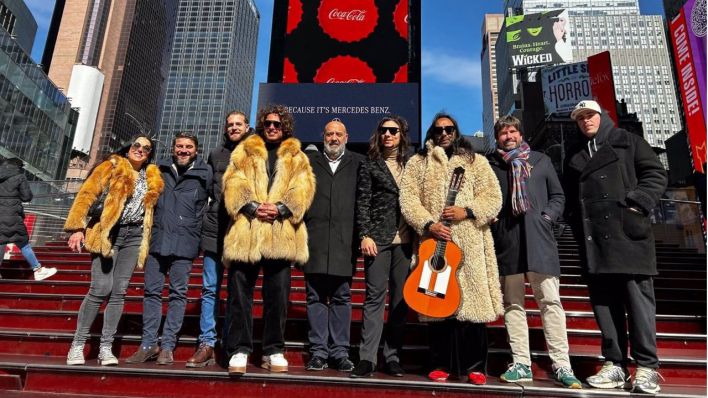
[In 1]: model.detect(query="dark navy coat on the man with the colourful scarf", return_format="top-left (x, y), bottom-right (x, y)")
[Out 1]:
top-left (489, 151), bottom-right (565, 276)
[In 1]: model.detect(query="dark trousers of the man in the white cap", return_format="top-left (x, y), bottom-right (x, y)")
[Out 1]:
top-left (588, 274), bottom-right (659, 369)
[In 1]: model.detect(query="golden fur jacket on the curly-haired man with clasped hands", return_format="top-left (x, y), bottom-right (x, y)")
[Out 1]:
top-left (223, 135), bottom-right (315, 264)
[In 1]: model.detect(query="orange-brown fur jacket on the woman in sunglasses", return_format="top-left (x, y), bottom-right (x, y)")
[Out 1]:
top-left (64, 155), bottom-right (165, 269)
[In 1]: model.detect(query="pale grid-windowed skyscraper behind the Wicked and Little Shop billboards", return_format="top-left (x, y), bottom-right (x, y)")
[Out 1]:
top-left (499, 0), bottom-right (681, 154)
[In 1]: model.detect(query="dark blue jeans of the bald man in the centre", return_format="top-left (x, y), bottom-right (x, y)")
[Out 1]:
top-left (305, 274), bottom-right (352, 360)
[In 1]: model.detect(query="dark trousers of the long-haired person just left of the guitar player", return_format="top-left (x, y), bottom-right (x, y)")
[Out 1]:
top-left (359, 244), bottom-right (411, 364)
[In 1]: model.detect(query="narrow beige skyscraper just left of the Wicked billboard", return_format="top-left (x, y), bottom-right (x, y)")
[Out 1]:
top-left (481, 14), bottom-right (504, 144)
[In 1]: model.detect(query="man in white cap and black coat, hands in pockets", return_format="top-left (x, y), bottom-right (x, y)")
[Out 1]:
top-left (564, 100), bottom-right (667, 394)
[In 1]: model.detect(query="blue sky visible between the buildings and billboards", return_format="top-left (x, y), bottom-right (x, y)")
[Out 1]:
top-left (25, 0), bottom-right (664, 135)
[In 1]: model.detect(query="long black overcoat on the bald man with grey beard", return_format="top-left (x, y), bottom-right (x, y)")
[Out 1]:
top-left (304, 151), bottom-right (364, 277)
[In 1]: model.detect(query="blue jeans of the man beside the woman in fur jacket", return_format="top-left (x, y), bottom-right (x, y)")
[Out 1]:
top-left (142, 254), bottom-right (192, 350)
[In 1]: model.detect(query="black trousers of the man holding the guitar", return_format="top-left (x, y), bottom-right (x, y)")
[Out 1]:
top-left (428, 319), bottom-right (488, 377)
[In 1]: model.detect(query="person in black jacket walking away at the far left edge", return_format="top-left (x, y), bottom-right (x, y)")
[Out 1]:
top-left (0, 158), bottom-right (57, 281)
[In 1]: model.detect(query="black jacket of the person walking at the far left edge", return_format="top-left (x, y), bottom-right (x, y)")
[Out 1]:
top-left (0, 163), bottom-right (32, 246)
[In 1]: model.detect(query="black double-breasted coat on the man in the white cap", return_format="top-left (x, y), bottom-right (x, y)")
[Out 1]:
top-left (564, 115), bottom-right (667, 275)
